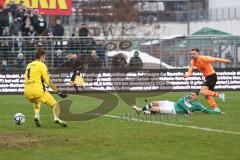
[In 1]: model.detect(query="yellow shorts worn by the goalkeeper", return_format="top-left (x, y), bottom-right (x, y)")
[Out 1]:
top-left (27, 91), bottom-right (57, 107)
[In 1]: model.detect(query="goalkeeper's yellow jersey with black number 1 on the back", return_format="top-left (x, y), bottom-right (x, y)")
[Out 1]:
top-left (24, 60), bottom-right (50, 99)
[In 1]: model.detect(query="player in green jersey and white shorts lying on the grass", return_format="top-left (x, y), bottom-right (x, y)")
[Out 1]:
top-left (133, 91), bottom-right (222, 114)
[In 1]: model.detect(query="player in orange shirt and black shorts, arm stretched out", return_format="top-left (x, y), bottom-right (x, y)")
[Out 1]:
top-left (184, 48), bottom-right (231, 111)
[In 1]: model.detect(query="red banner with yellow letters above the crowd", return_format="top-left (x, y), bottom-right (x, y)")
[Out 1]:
top-left (0, 0), bottom-right (72, 15)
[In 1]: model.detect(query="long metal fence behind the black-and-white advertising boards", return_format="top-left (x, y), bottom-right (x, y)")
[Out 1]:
top-left (0, 36), bottom-right (240, 71)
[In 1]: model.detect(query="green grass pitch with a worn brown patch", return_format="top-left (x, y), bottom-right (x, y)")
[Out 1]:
top-left (0, 92), bottom-right (240, 160)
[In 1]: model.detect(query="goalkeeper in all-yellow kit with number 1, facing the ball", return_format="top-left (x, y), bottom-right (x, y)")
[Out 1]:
top-left (24, 49), bottom-right (67, 127)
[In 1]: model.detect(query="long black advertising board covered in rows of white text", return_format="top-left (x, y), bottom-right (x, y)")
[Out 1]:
top-left (0, 69), bottom-right (240, 94)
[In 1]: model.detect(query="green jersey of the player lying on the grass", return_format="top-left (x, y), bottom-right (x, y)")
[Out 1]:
top-left (174, 95), bottom-right (220, 114)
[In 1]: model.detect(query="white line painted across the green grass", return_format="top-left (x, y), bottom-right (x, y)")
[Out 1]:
top-left (102, 115), bottom-right (240, 135)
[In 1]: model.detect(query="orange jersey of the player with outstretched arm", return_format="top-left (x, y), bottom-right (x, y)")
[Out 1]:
top-left (191, 56), bottom-right (216, 77)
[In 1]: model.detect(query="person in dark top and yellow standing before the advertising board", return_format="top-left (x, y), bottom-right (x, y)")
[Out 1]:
top-left (70, 69), bottom-right (85, 93)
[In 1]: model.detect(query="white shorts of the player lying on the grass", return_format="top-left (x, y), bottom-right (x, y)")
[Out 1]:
top-left (159, 100), bottom-right (176, 114)
